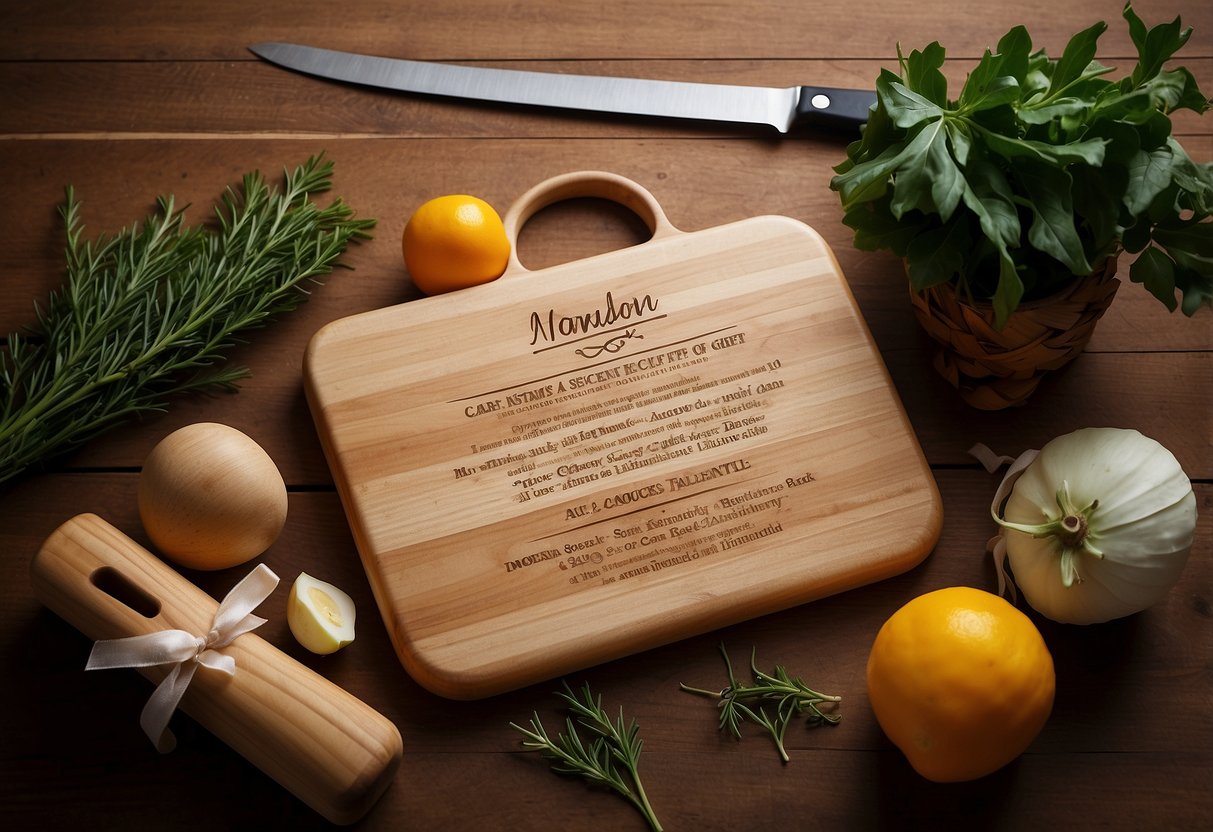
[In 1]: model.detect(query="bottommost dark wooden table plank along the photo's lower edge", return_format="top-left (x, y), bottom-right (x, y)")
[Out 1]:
top-left (8, 736), bottom-right (1213, 832)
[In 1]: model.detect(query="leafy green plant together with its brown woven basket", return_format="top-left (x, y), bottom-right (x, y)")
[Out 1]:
top-left (831, 4), bottom-right (1213, 409)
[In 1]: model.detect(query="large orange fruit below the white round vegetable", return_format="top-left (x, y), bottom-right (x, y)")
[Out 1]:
top-left (867, 587), bottom-right (1055, 782)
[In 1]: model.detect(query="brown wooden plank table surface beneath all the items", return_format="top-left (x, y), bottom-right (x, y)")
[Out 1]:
top-left (0, 0), bottom-right (1213, 830)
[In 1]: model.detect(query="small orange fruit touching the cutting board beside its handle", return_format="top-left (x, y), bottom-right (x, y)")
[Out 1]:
top-left (402, 194), bottom-right (509, 295)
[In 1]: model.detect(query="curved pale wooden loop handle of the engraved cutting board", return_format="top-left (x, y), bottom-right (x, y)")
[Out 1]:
top-left (502, 171), bottom-right (678, 277)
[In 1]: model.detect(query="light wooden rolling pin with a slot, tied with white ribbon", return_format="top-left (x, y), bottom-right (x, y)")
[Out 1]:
top-left (30, 514), bottom-right (403, 824)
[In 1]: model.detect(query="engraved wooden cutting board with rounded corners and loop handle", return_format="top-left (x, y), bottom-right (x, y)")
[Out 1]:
top-left (304, 172), bottom-right (943, 699)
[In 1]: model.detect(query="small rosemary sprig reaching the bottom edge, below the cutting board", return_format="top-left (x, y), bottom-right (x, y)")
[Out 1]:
top-left (509, 682), bottom-right (661, 832)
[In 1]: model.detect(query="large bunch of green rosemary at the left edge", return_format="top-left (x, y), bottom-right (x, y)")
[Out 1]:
top-left (0, 156), bottom-right (375, 483)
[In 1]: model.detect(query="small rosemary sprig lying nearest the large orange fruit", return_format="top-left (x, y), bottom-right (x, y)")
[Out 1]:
top-left (678, 644), bottom-right (842, 763)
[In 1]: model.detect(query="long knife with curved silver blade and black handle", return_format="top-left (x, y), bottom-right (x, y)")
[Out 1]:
top-left (249, 42), bottom-right (876, 133)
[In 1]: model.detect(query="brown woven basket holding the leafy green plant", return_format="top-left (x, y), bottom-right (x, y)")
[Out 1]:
top-left (910, 257), bottom-right (1120, 410)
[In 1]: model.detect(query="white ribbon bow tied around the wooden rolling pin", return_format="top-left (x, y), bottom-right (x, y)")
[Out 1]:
top-left (85, 564), bottom-right (278, 754)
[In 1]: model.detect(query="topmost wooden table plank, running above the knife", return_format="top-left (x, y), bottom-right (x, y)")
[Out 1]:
top-left (0, 0), bottom-right (1213, 61)
